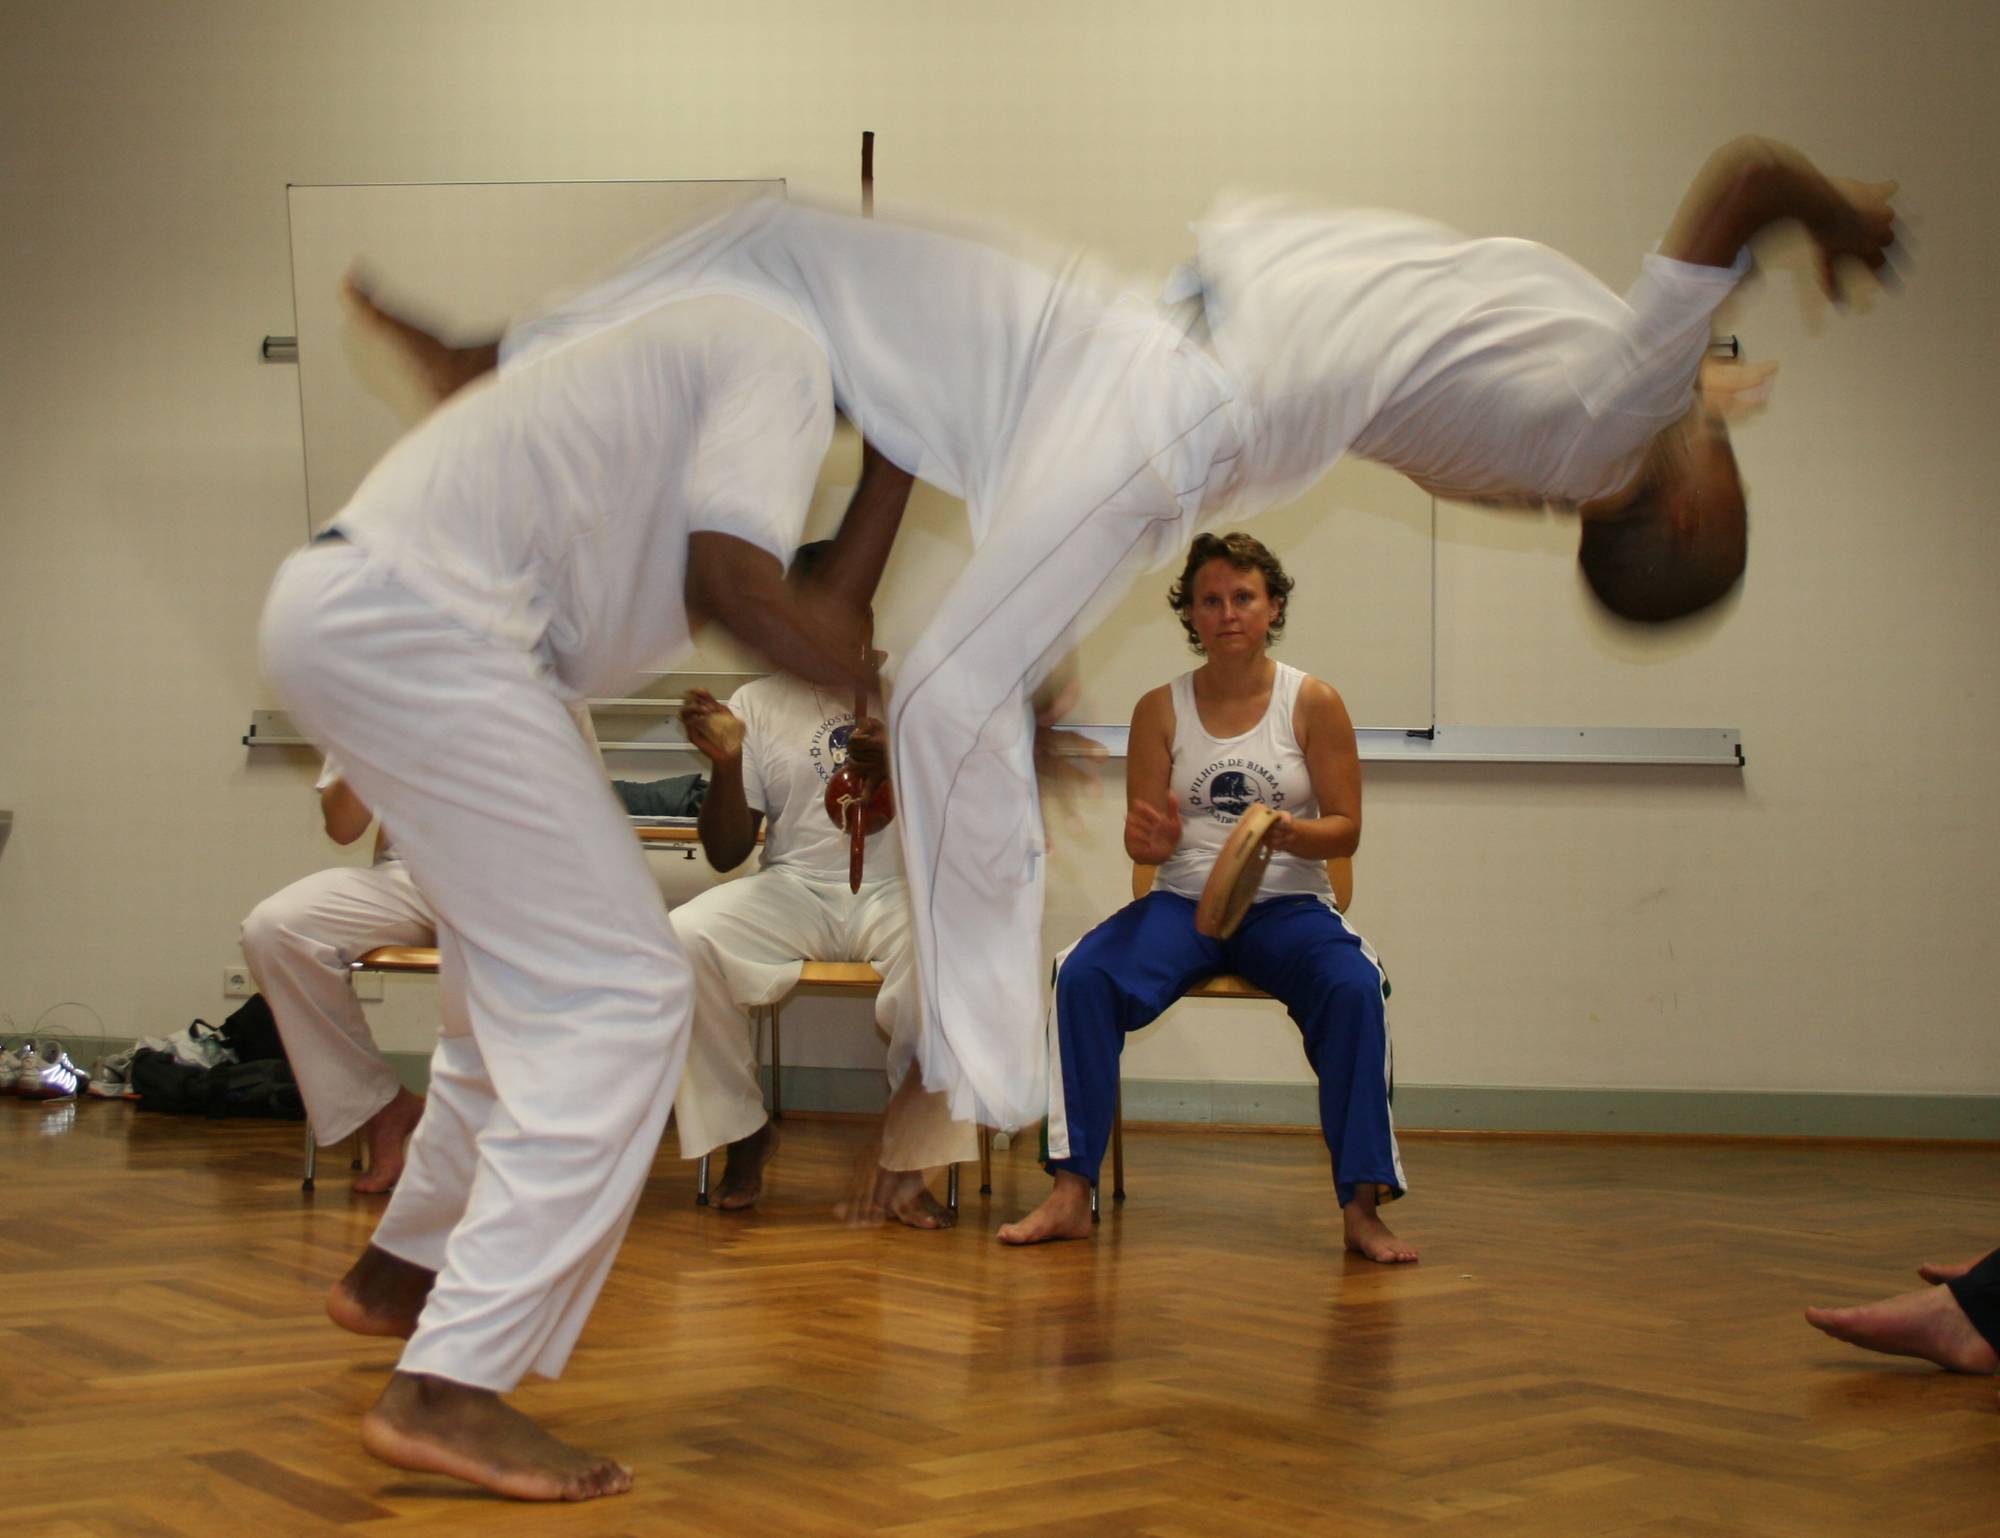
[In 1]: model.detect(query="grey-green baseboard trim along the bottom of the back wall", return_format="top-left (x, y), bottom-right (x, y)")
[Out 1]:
top-left (360, 1052), bottom-right (2000, 1142)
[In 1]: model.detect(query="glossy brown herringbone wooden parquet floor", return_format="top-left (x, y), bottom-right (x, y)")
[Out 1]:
top-left (0, 1100), bottom-right (2000, 1538)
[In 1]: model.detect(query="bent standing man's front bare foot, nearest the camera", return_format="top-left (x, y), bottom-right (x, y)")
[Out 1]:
top-left (362, 1372), bottom-right (632, 1500)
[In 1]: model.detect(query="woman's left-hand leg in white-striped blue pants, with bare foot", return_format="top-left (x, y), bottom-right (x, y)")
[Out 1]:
top-left (1000, 892), bottom-right (1222, 1244)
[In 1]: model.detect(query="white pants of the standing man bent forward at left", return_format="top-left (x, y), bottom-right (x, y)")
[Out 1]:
top-left (262, 544), bottom-right (692, 1390)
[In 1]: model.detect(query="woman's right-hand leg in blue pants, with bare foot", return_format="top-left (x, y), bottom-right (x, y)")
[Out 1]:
top-left (1226, 896), bottom-right (1416, 1262)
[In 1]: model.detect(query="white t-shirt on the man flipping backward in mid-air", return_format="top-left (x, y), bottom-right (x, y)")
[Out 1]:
top-left (1194, 202), bottom-right (1748, 506)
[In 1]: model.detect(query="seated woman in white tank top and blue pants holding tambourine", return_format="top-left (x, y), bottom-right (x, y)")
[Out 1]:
top-left (1000, 534), bottom-right (1416, 1264)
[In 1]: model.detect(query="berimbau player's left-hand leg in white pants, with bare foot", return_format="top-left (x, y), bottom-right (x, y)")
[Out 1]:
top-left (670, 870), bottom-right (824, 1212)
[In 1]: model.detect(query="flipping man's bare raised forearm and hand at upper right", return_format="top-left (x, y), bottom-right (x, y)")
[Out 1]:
top-left (1660, 136), bottom-right (1896, 300)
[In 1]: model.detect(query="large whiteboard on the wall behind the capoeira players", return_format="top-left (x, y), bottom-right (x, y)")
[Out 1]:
top-left (288, 180), bottom-right (1434, 728)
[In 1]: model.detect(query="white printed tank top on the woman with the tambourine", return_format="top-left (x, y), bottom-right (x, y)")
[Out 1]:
top-left (1154, 662), bottom-right (1334, 902)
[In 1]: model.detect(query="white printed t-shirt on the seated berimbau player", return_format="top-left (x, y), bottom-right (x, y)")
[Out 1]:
top-left (730, 674), bottom-right (902, 882)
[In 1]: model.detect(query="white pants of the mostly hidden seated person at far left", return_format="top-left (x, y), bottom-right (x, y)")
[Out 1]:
top-left (242, 858), bottom-right (438, 1144)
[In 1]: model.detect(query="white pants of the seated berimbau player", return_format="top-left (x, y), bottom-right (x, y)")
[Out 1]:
top-left (672, 866), bottom-right (978, 1170)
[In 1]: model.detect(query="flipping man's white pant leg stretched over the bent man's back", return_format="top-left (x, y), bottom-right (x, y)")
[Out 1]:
top-left (500, 198), bottom-right (1156, 542)
